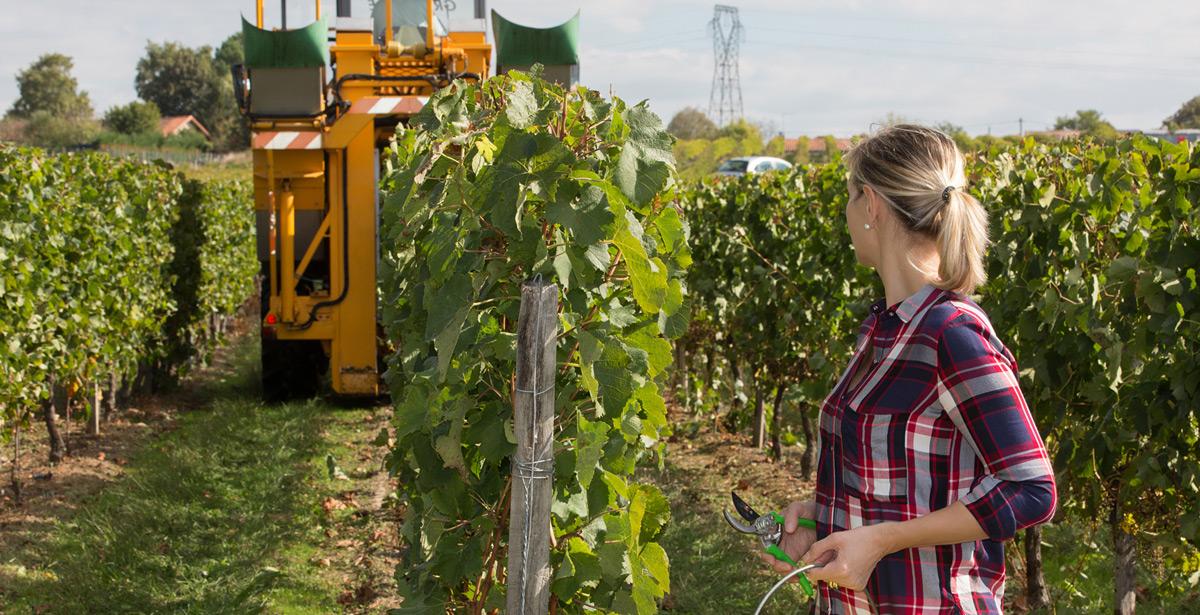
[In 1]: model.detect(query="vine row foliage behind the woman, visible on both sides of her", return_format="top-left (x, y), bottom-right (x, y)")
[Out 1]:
top-left (682, 136), bottom-right (1200, 605)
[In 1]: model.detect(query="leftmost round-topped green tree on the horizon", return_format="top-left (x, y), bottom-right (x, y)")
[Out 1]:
top-left (8, 53), bottom-right (91, 119)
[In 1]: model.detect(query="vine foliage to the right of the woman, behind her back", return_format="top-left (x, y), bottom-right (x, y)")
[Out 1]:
top-left (973, 136), bottom-right (1200, 559)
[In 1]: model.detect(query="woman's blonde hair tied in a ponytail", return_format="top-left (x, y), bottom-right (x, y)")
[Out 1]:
top-left (845, 124), bottom-right (988, 294)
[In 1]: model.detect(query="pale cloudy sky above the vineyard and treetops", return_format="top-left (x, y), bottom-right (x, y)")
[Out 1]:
top-left (0, 0), bottom-right (1200, 137)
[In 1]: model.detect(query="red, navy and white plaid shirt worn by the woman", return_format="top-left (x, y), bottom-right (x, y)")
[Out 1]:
top-left (816, 285), bottom-right (1057, 614)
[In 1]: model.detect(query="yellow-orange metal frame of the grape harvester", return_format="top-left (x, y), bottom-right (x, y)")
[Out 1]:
top-left (251, 0), bottom-right (492, 395)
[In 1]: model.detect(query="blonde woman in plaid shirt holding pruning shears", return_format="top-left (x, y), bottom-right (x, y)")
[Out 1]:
top-left (766, 125), bottom-right (1057, 614)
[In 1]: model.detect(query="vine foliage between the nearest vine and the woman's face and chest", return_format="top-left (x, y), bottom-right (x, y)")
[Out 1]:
top-left (680, 164), bottom-right (878, 437)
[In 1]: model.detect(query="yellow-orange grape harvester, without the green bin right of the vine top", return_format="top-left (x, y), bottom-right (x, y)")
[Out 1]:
top-left (233, 0), bottom-right (492, 400)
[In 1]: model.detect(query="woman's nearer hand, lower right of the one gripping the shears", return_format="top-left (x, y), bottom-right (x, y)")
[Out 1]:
top-left (800, 524), bottom-right (894, 590)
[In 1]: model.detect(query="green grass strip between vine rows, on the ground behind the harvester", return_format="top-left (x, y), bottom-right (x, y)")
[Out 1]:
top-left (5, 341), bottom-right (367, 614)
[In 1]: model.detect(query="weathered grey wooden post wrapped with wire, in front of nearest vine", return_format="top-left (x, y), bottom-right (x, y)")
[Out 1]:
top-left (506, 279), bottom-right (558, 615)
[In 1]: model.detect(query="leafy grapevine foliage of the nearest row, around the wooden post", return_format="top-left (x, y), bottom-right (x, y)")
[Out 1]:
top-left (380, 73), bottom-right (691, 613)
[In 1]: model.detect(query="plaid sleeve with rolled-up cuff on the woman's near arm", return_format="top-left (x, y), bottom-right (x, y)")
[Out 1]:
top-left (937, 312), bottom-right (1057, 541)
